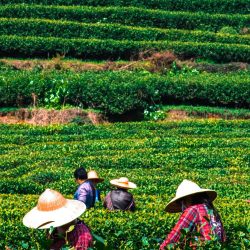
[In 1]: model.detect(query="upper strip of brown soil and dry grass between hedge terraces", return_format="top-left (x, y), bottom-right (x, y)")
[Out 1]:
top-left (0, 57), bottom-right (250, 73)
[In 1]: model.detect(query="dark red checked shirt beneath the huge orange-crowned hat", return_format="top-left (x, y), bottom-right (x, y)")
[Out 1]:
top-left (50, 220), bottom-right (93, 250)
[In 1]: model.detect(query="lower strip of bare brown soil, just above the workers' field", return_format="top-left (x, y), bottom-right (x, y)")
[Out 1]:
top-left (0, 108), bottom-right (246, 126)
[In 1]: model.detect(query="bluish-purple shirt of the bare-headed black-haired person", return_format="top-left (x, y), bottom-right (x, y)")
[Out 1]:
top-left (74, 180), bottom-right (95, 208)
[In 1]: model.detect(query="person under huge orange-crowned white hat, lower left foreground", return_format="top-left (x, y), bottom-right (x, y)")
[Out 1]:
top-left (23, 189), bottom-right (93, 250)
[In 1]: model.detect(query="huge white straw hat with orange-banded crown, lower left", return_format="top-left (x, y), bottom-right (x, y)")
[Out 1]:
top-left (23, 189), bottom-right (86, 229)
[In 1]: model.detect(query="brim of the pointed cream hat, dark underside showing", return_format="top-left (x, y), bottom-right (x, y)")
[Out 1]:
top-left (165, 189), bottom-right (217, 213)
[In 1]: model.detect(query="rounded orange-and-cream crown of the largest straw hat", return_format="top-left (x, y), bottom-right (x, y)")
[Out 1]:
top-left (37, 189), bottom-right (67, 212)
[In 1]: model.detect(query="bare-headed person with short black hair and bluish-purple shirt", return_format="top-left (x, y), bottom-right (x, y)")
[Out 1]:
top-left (74, 167), bottom-right (95, 208)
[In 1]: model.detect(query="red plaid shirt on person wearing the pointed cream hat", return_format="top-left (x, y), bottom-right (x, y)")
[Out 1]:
top-left (160, 204), bottom-right (225, 250)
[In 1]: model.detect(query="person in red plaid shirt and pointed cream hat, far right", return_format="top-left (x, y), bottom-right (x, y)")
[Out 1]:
top-left (160, 180), bottom-right (226, 250)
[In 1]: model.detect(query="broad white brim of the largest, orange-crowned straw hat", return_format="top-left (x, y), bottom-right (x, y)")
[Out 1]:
top-left (23, 199), bottom-right (86, 229)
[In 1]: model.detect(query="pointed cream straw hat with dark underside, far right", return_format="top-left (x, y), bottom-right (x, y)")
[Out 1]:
top-left (165, 180), bottom-right (217, 213)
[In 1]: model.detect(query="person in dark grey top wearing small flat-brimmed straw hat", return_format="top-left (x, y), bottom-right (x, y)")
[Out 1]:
top-left (103, 177), bottom-right (136, 211)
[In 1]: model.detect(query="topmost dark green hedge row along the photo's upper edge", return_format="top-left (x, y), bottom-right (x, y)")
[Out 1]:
top-left (1, 0), bottom-right (250, 14)
